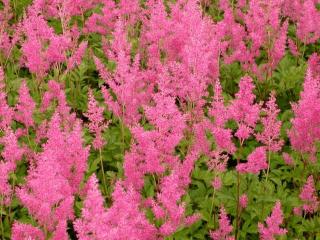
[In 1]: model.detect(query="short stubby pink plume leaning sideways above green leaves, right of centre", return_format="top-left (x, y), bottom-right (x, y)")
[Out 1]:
top-left (237, 147), bottom-right (268, 174)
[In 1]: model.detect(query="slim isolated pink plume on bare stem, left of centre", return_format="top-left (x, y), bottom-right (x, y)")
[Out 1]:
top-left (84, 89), bottom-right (108, 149)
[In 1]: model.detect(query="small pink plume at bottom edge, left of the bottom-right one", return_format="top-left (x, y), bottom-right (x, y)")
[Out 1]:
top-left (210, 207), bottom-right (234, 240)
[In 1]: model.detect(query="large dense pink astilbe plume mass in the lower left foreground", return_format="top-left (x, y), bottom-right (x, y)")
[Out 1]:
top-left (15, 113), bottom-right (88, 239)
